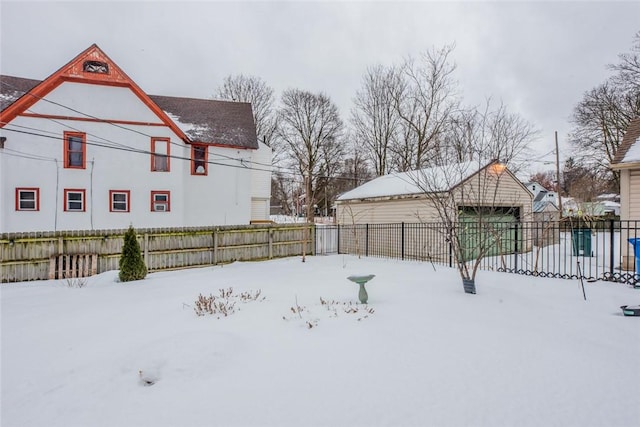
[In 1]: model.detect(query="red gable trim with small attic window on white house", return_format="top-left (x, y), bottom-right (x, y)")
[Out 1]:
top-left (0, 44), bottom-right (189, 142)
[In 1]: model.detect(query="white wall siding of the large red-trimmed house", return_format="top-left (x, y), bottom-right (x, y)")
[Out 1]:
top-left (0, 83), bottom-right (253, 232)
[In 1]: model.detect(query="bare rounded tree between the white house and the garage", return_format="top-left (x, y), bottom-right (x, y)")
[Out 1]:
top-left (278, 89), bottom-right (342, 222)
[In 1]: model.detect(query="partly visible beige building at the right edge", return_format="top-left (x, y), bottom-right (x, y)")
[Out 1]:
top-left (611, 117), bottom-right (640, 270)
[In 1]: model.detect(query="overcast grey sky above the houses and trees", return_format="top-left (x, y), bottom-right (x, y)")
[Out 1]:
top-left (0, 0), bottom-right (640, 174)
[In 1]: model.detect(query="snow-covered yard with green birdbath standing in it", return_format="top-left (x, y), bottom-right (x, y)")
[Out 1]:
top-left (0, 255), bottom-right (640, 427)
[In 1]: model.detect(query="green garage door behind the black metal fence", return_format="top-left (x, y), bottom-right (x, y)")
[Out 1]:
top-left (460, 211), bottom-right (521, 261)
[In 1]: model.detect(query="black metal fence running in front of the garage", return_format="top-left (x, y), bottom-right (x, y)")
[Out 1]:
top-left (315, 219), bottom-right (640, 286)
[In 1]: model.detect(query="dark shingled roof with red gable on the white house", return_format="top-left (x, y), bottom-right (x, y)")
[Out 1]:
top-left (0, 44), bottom-right (258, 149)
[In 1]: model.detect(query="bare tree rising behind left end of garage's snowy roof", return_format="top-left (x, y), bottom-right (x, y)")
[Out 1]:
top-left (351, 65), bottom-right (402, 176)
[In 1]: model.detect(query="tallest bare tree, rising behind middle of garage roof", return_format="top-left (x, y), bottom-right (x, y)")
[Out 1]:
top-left (391, 45), bottom-right (459, 171)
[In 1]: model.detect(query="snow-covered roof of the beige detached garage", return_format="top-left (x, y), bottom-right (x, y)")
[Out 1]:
top-left (338, 160), bottom-right (516, 201)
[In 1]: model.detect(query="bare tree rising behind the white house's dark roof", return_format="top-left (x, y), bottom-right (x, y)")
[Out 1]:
top-left (217, 74), bottom-right (277, 146)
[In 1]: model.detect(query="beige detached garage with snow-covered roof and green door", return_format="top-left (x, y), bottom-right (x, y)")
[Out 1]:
top-left (336, 162), bottom-right (532, 259)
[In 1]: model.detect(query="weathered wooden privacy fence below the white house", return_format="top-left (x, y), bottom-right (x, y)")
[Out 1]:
top-left (0, 224), bottom-right (314, 283)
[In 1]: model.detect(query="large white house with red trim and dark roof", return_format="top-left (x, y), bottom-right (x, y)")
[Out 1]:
top-left (0, 44), bottom-right (271, 232)
